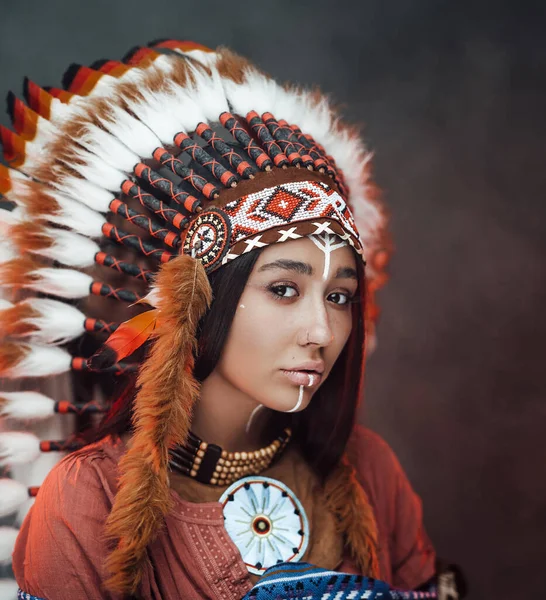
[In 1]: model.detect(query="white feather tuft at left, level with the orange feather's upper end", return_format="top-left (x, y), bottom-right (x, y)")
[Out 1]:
top-left (15, 298), bottom-right (85, 344)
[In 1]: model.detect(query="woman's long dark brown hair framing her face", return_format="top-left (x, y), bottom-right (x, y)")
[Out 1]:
top-left (88, 250), bottom-right (365, 481)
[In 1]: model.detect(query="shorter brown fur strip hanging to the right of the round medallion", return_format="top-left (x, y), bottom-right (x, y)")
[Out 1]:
top-left (325, 456), bottom-right (379, 578)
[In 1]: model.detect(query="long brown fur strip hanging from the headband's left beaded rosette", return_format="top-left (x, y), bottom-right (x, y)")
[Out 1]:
top-left (106, 256), bottom-right (212, 594)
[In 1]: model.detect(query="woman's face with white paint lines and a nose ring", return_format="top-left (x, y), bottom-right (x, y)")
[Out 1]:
top-left (215, 238), bottom-right (358, 412)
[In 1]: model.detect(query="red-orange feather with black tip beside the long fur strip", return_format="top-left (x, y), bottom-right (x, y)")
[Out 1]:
top-left (88, 310), bottom-right (157, 370)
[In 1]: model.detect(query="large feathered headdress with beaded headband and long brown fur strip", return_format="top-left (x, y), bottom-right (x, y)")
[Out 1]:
top-left (0, 41), bottom-right (386, 592)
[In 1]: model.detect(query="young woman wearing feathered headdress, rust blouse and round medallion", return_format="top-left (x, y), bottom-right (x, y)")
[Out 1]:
top-left (0, 42), bottom-right (435, 600)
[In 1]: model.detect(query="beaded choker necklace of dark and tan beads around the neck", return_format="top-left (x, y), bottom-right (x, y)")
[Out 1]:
top-left (169, 429), bottom-right (292, 485)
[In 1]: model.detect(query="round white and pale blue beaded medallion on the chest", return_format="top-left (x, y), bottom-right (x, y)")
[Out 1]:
top-left (219, 476), bottom-right (309, 575)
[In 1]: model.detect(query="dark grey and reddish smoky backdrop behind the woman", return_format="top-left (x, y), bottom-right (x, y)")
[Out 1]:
top-left (0, 0), bottom-right (546, 600)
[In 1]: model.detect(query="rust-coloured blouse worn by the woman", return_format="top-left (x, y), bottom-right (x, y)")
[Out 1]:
top-left (13, 427), bottom-right (435, 600)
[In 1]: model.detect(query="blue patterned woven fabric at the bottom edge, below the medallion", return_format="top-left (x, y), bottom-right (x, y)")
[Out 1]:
top-left (242, 562), bottom-right (438, 600)
